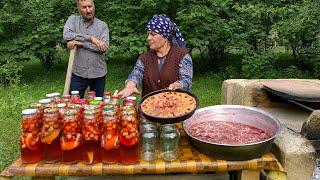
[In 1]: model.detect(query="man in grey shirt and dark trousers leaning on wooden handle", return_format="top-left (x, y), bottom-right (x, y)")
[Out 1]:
top-left (63, 0), bottom-right (109, 98)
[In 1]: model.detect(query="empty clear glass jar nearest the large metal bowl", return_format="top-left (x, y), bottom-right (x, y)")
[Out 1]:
top-left (160, 124), bottom-right (180, 161)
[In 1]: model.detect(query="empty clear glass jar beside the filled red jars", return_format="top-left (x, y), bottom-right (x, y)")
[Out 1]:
top-left (140, 123), bottom-right (158, 161)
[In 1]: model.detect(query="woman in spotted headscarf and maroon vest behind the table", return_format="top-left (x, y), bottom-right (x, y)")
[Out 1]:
top-left (119, 14), bottom-right (193, 97)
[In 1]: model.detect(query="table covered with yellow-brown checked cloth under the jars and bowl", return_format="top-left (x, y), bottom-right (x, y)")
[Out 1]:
top-left (1, 124), bottom-right (284, 180)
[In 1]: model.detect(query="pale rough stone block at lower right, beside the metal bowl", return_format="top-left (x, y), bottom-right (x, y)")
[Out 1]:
top-left (273, 126), bottom-right (316, 180)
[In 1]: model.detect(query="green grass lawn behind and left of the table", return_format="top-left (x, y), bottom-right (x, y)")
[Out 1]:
top-left (0, 60), bottom-right (222, 175)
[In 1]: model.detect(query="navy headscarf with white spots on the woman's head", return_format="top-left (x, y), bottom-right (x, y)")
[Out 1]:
top-left (147, 14), bottom-right (186, 47)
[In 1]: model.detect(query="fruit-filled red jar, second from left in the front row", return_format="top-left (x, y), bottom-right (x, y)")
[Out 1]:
top-left (41, 108), bottom-right (61, 163)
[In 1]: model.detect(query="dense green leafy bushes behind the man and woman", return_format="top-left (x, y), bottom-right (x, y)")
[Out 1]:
top-left (0, 0), bottom-right (320, 85)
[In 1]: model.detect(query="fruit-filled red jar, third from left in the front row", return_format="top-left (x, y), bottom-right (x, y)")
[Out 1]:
top-left (60, 109), bottom-right (82, 164)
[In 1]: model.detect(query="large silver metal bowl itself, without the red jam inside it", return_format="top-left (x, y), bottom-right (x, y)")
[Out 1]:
top-left (183, 105), bottom-right (281, 160)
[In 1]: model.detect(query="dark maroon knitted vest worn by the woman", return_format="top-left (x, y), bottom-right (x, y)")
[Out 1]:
top-left (140, 46), bottom-right (188, 97)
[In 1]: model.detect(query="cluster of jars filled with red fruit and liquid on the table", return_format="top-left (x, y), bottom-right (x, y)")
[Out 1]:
top-left (20, 94), bottom-right (139, 164)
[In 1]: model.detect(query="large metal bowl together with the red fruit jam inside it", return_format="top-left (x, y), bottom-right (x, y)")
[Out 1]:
top-left (183, 105), bottom-right (281, 160)
